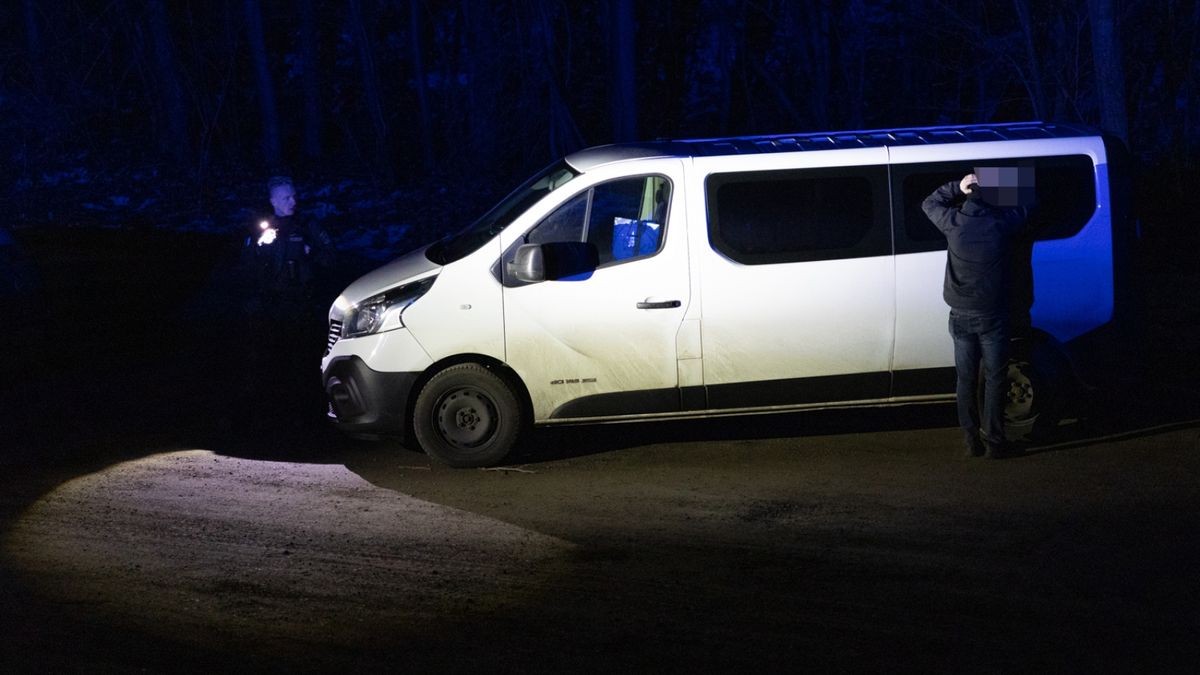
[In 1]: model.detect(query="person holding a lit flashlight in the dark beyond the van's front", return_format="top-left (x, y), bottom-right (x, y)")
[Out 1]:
top-left (240, 175), bottom-right (335, 415)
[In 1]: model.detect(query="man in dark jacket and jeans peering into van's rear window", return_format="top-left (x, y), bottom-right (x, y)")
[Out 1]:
top-left (922, 173), bottom-right (1027, 459)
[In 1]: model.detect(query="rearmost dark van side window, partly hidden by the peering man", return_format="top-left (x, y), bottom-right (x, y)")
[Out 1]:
top-left (892, 155), bottom-right (1096, 253)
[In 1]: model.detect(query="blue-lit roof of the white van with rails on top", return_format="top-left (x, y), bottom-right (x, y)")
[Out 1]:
top-left (566, 121), bottom-right (1100, 172)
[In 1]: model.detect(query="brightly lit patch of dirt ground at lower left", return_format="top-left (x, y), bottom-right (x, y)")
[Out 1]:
top-left (4, 450), bottom-right (574, 643)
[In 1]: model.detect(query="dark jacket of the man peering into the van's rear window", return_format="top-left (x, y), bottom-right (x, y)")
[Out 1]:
top-left (920, 181), bottom-right (1028, 312)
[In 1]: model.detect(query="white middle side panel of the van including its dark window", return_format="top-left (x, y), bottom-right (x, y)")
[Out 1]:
top-left (689, 148), bottom-right (895, 401)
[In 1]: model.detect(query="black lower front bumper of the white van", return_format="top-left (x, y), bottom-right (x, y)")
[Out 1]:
top-left (322, 356), bottom-right (421, 437)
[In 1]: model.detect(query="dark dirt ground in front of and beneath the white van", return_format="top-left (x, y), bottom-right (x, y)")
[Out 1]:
top-left (0, 401), bottom-right (1200, 671)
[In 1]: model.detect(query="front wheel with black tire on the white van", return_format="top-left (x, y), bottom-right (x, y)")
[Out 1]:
top-left (413, 363), bottom-right (523, 468)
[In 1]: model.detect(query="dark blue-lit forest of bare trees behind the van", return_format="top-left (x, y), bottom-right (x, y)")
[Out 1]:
top-left (0, 0), bottom-right (1200, 257)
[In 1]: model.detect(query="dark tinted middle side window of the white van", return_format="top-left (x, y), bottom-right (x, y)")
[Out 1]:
top-left (706, 166), bottom-right (892, 264)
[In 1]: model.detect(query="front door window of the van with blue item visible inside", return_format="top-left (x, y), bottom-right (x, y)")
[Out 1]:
top-left (526, 175), bottom-right (671, 267)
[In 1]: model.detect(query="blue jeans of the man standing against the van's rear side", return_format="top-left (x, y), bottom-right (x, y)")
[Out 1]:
top-left (950, 310), bottom-right (1009, 443)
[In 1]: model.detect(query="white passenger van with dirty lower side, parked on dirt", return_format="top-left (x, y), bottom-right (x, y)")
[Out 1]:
top-left (322, 123), bottom-right (1117, 466)
